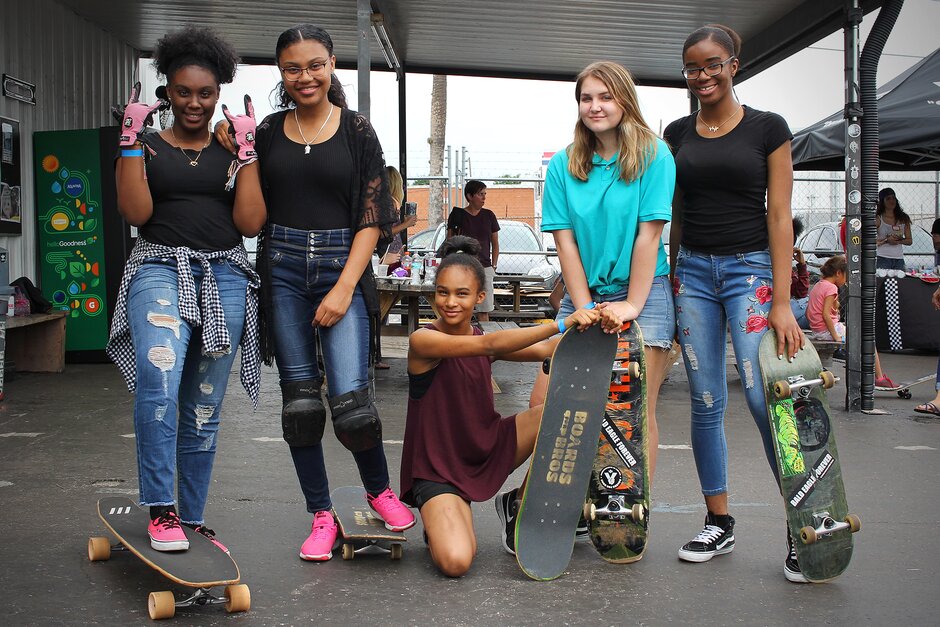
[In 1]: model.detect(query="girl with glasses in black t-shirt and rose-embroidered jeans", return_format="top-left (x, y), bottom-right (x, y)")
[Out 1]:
top-left (664, 25), bottom-right (806, 581)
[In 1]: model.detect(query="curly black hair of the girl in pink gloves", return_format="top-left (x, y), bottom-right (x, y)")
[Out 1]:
top-left (153, 26), bottom-right (239, 85)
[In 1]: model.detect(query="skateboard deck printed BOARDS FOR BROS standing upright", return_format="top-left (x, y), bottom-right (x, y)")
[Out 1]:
top-left (515, 325), bottom-right (617, 581)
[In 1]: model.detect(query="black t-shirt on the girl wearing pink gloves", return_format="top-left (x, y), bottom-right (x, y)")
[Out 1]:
top-left (140, 133), bottom-right (242, 252)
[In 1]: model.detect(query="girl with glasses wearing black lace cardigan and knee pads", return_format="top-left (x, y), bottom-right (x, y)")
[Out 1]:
top-left (216, 24), bottom-right (415, 561)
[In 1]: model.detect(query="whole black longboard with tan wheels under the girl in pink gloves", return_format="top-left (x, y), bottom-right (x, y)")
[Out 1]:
top-left (88, 497), bottom-right (251, 619)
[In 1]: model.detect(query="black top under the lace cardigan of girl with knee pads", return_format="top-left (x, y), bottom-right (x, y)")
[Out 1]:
top-left (261, 119), bottom-right (358, 231)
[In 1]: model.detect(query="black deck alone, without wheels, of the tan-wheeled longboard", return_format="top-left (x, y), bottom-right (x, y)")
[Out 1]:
top-left (98, 497), bottom-right (240, 588)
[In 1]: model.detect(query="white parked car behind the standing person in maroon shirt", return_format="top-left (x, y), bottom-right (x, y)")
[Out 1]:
top-left (408, 220), bottom-right (561, 288)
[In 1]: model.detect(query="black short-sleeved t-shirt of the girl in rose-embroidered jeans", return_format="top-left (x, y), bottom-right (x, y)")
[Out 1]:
top-left (663, 107), bottom-right (793, 255)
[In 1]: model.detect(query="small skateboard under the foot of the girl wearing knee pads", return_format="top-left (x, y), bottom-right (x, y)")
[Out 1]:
top-left (330, 486), bottom-right (407, 560)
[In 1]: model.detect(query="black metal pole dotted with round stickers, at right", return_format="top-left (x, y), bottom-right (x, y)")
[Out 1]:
top-left (844, 0), bottom-right (862, 411)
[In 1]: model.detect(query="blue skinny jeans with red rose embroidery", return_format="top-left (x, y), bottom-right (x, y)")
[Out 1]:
top-left (673, 247), bottom-right (777, 496)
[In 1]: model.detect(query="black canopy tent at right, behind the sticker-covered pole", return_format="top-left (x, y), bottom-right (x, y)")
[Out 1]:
top-left (793, 49), bottom-right (940, 171)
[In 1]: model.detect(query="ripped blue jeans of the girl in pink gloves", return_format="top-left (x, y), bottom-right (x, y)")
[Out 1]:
top-left (127, 259), bottom-right (248, 525)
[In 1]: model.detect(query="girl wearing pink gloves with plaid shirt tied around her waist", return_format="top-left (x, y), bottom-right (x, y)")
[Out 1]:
top-left (107, 27), bottom-right (264, 551)
